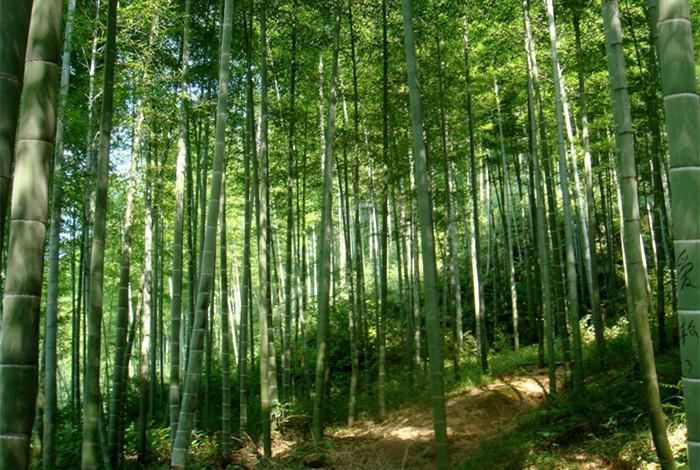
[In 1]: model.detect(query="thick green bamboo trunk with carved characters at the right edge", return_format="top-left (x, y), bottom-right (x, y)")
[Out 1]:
top-left (655, 0), bottom-right (700, 468)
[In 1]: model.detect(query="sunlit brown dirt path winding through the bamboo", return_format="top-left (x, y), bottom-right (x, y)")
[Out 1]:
top-left (316, 370), bottom-right (548, 469)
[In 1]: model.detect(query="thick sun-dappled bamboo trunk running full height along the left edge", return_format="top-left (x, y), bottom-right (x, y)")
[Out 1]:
top-left (0, 0), bottom-right (63, 469)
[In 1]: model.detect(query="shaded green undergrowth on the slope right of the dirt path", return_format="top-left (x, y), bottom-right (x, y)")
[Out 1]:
top-left (457, 335), bottom-right (686, 470)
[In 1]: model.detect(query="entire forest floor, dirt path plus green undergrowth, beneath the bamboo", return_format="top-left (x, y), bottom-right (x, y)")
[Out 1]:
top-left (112, 328), bottom-right (686, 470)
